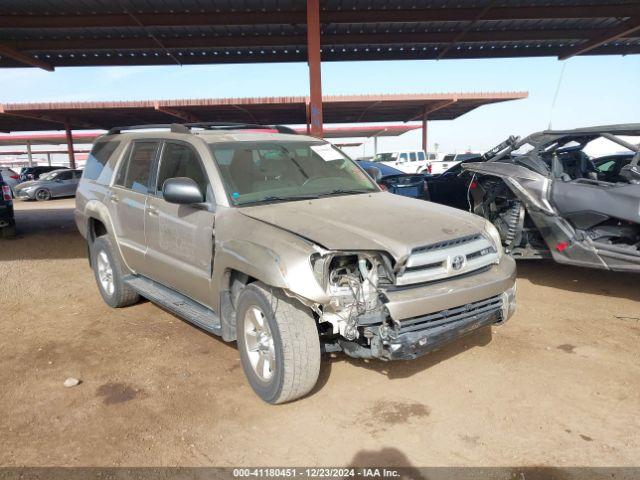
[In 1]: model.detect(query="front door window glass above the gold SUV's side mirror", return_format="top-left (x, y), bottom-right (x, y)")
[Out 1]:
top-left (156, 143), bottom-right (210, 202)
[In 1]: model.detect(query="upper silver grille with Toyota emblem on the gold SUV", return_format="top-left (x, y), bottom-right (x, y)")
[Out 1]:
top-left (395, 234), bottom-right (499, 286)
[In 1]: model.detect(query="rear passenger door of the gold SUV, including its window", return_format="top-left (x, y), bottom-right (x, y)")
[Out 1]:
top-left (106, 140), bottom-right (160, 274)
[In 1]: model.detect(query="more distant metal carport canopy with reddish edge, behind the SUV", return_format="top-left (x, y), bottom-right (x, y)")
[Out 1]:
top-left (0, 92), bottom-right (527, 132)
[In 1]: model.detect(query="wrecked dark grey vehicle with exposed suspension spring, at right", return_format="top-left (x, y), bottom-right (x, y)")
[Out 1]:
top-left (462, 124), bottom-right (640, 272)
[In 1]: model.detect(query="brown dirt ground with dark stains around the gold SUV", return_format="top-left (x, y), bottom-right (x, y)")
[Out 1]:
top-left (0, 199), bottom-right (640, 466)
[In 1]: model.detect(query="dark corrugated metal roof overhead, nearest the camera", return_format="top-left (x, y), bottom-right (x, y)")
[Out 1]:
top-left (0, 0), bottom-right (640, 67)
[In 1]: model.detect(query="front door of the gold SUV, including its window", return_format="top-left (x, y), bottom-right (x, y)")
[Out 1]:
top-left (145, 141), bottom-right (215, 306)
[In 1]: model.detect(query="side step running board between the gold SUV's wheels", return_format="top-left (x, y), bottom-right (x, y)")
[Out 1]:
top-left (124, 275), bottom-right (222, 335)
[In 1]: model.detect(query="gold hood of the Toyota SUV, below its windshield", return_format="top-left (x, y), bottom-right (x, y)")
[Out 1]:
top-left (240, 192), bottom-right (484, 260)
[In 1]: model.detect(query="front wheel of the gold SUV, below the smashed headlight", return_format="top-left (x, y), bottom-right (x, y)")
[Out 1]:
top-left (236, 282), bottom-right (320, 404)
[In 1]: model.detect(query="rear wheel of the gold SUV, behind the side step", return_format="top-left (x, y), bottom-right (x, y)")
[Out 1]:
top-left (90, 235), bottom-right (140, 308)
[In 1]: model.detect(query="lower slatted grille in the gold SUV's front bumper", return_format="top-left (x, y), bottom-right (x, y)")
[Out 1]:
top-left (396, 295), bottom-right (502, 334)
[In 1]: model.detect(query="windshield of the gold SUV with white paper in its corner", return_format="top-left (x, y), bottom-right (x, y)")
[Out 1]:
top-left (211, 142), bottom-right (378, 205)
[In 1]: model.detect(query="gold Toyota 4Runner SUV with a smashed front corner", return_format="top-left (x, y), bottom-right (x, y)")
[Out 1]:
top-left (75, 123), bottom-right (515, 403)
